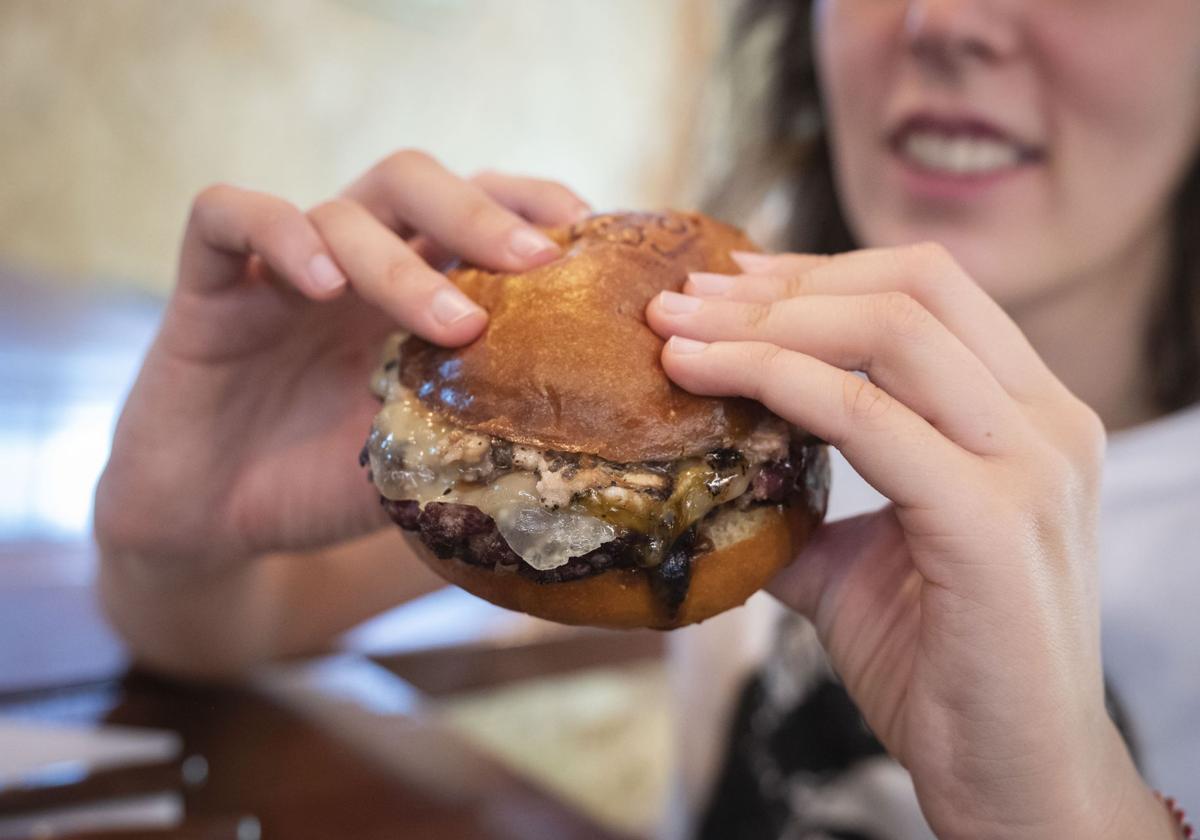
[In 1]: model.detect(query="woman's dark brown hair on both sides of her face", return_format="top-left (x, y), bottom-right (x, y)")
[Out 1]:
top-left (707, 0), bottom-right (1200, 413)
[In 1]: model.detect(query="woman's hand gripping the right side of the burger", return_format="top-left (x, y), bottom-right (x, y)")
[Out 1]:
top-left (647, 245), bottom-right (1170, 839)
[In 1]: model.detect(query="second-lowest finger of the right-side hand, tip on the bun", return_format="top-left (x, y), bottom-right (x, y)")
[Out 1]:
top-left (647, 292), bottom-right (1025, 455)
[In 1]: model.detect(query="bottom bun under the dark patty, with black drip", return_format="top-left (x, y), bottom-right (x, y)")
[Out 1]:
top-left (406, 494), bottom-right (824, 630)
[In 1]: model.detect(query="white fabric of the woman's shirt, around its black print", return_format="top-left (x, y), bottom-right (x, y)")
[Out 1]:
top-left (664, 407), bottom-right (1200, 840)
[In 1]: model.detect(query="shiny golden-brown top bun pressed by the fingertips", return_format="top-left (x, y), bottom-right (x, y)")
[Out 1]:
top-left (400, 211), bottom-right (764, 463)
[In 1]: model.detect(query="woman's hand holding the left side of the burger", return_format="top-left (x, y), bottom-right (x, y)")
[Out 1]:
top-left (96, 151), bottom-right (588, 576)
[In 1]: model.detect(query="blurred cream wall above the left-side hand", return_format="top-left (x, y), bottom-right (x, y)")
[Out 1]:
top-left (0, 0), bottom-right (714, 292)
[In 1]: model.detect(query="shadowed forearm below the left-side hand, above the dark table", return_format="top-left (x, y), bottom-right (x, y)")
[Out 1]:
top-left (100, 530), bottom-right (442, 679)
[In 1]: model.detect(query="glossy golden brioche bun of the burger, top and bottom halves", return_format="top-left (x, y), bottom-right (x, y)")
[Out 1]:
top-left (379, 212), bottom-right (829, 630)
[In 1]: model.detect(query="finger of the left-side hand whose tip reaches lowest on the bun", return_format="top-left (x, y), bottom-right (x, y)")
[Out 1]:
top-left (308, 198), bottom-right (487, 347)
